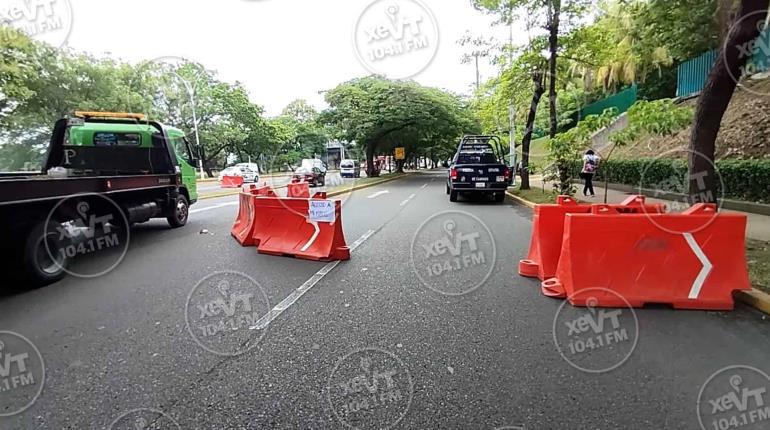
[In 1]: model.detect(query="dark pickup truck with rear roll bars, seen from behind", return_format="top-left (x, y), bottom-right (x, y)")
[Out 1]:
top-left (446, 136), bottom-right (511, 202)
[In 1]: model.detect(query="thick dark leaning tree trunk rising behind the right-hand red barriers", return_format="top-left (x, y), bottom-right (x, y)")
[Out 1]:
top-left (688, 0), bottom-right (767, 203)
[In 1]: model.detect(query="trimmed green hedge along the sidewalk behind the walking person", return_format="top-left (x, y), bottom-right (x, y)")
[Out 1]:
top-left (573, 158), bottom-right (770, 203)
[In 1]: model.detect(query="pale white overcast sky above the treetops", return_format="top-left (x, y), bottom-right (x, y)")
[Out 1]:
top-left (18, 0), bottom-right (527, 116)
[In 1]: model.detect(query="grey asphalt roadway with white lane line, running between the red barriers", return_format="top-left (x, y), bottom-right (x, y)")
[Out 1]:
top-left (0, 172), bottom-right (770, 430)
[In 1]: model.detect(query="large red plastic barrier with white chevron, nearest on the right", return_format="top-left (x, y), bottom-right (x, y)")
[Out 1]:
top-left (543, 204), bottom-right (751, 310)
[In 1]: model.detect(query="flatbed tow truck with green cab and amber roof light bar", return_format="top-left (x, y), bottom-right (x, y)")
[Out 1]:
top-left (0, 112), bottom-right (198, 287)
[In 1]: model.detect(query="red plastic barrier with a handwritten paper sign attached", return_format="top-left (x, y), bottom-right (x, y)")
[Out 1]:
top-left (249, 197), bottom-right (350, 261)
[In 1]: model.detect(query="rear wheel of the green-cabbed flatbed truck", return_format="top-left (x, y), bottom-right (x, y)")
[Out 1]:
top-left (22, 221), bottom-right (68, 287)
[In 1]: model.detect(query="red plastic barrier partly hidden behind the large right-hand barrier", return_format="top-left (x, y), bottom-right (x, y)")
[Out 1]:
top-left (519, 196), bottom-right (666, 281)
